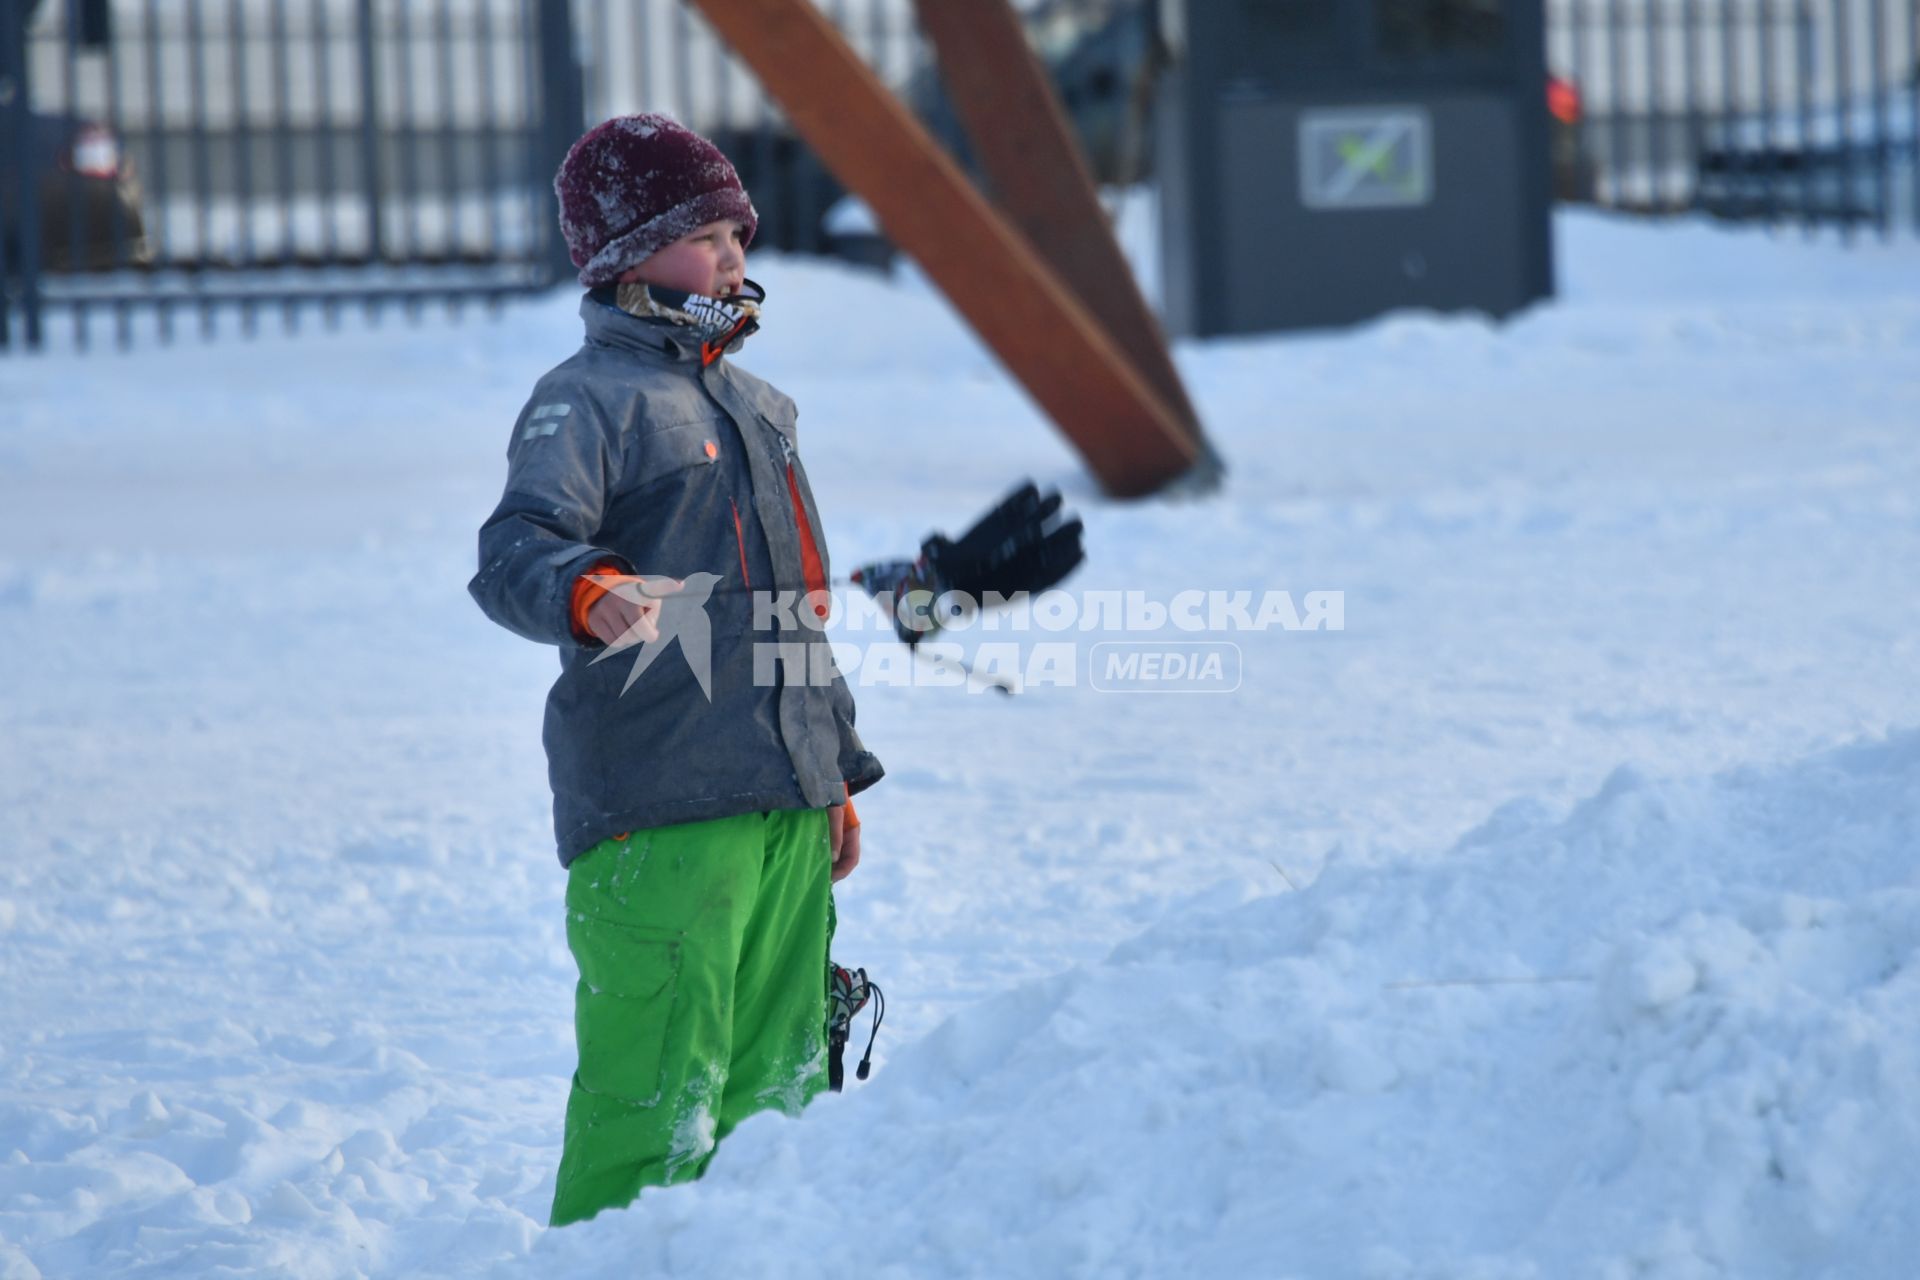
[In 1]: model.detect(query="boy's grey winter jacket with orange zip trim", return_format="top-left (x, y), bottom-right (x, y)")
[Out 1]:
top-left (467, 292), bottom-right (883, 865)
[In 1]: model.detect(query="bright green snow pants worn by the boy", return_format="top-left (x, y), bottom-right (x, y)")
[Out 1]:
top-left (551, 810), bottom-right (833, 1226)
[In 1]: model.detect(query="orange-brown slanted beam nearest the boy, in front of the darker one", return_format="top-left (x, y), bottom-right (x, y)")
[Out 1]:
top-left (697, 0), bottom-right (1200, 497)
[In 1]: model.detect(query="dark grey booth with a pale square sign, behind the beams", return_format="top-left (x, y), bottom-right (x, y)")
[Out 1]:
top-left (1154, 0), bottom-right (1553, 336)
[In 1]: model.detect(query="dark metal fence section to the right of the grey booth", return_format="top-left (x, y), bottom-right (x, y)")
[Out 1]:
top-left (1548, 0), bottom-right (1920, 234)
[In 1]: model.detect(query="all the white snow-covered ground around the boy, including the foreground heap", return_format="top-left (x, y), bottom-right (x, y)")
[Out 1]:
top-left (0, 217), bottom-right (1920, 1280)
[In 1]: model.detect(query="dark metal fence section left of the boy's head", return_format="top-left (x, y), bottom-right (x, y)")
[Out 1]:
top-left (0, 0), bottom-right (582, 347)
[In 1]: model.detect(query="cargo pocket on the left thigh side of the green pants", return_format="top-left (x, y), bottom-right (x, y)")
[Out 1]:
top-left (566, 912), bottom-right (680, 1107)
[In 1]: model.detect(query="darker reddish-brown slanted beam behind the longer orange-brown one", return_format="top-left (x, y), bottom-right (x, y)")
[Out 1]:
top-left (914, 0), bottom-right (1202, 458)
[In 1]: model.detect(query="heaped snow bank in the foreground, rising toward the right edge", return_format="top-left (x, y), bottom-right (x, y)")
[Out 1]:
top-left (534, 733), bottom-right (1920, 1280)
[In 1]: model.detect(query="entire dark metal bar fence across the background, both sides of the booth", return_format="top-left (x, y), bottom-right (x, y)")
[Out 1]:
top-left (0, 0), bottom-right (1920, 347)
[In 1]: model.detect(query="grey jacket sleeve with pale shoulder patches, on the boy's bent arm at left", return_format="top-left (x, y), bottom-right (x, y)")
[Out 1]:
top-left (467, 391), bottom-right (620, 645)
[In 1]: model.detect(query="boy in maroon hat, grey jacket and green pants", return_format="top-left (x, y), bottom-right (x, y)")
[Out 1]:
top-left (468, 115), bottom-right (883, 1226)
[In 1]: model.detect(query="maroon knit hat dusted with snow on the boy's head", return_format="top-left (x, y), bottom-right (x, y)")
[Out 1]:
top-left (553, 115), bottom-right (760, 288)
